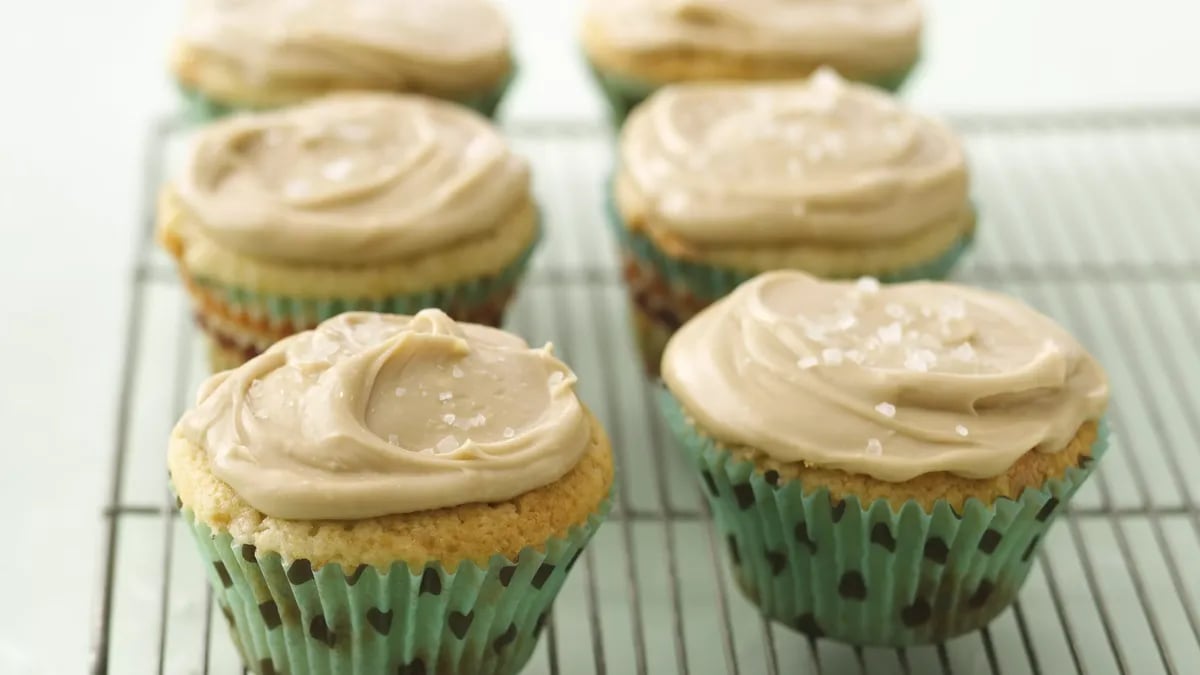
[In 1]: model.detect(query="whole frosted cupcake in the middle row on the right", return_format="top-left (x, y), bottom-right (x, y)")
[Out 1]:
top-left (610, 70), bottom-right (976, 372)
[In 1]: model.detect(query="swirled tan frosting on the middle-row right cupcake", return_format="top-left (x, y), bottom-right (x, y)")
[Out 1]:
top-left (617, 70), bottom-right (973, 246)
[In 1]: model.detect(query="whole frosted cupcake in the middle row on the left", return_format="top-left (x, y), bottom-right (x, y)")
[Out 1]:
top-left (158, 94), bottom-right (539, 370)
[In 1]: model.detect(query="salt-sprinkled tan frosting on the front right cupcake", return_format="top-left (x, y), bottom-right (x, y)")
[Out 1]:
top-left (662, 271), bottom-right (1109, 482)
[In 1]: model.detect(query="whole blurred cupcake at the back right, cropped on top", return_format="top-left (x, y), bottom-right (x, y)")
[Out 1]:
top-left (582, 0), bottom-right (922, 121)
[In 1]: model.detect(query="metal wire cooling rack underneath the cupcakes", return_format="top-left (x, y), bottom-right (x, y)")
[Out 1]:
top-left (94, 109), bottom-right (1200, 675)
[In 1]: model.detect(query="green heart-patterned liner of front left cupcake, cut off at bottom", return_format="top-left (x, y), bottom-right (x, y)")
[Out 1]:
top-left (181, 498), bottom-right (611, 675)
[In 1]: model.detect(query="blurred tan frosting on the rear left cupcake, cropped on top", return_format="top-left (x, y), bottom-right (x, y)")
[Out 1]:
top-left (180, 0), bottom-right (511, 91)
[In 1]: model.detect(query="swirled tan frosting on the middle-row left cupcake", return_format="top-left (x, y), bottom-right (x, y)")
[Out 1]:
top-left (174, 91), bottom-right (529, 263)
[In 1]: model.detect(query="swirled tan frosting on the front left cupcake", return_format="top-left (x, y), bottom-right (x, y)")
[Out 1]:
top-left (179, 310), bottom-right (590, 520)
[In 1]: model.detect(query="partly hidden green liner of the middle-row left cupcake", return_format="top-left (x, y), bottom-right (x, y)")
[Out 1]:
top-left (184, 233), bottom-right (538, 330)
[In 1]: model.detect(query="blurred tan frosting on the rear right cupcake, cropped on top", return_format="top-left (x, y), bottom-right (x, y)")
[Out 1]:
top-left (586, 0), bottom-right (922, 64)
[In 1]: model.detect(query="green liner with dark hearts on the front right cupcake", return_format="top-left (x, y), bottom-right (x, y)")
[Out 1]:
top-left (660, 390), bottom-right (1108, 646)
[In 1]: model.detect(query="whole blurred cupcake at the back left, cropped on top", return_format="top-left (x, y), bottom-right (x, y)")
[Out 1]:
top-left (170, 0), bottom-right (514, 120)
